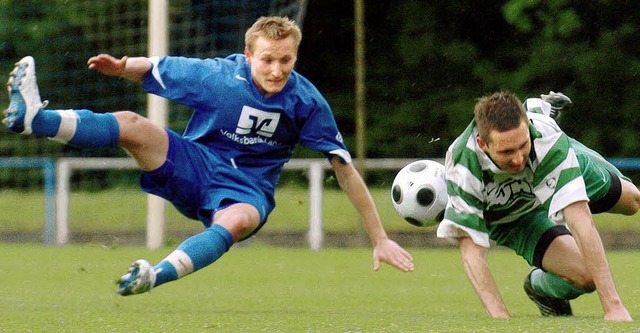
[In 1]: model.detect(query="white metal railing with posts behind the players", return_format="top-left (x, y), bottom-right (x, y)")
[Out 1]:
top-left (55, 158), bottom-right (422, 251)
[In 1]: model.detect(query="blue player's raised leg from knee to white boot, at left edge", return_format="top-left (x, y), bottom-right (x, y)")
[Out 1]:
top-left (2, 57), bottom-right (168, 170)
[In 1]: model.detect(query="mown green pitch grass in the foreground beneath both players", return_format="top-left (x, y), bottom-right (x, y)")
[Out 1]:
top-left (0, 244), bottom-right (640, 332)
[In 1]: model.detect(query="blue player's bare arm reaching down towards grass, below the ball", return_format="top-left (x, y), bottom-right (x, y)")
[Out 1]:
top-left (331, 157), bottom-right (414, 272)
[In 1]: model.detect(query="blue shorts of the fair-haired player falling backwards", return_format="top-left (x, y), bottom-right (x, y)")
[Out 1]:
top-left (140, 129), bottom-right (275, 233)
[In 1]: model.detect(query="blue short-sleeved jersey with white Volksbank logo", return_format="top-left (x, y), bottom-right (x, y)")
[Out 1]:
top-left (143, 54), bottom-right (351, 192)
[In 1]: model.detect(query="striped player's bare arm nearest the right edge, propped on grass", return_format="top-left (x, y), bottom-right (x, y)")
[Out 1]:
top-left (562, 201), bottom-right (632, 321)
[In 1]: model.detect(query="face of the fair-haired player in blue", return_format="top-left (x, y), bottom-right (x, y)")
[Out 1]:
top-left (244, 37), bottom-right (298, 97)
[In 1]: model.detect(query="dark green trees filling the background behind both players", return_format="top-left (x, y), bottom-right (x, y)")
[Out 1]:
top-left (0, 0), bottom-right (640, 187)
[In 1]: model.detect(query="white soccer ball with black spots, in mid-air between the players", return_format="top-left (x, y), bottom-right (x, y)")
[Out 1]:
top-left (391, 160), bottom-right (449, 227)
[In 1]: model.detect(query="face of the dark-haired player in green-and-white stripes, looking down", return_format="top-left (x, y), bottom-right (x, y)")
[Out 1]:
top-left (477, 122), bottom-right (531, 175)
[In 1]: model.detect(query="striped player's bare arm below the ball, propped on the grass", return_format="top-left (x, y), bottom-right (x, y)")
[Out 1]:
top-left (458, 237), bottom-right (510, 319)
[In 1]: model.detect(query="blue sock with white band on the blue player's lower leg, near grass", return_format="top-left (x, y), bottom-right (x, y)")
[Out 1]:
top-left (153, 224), bottom-right (233, 287)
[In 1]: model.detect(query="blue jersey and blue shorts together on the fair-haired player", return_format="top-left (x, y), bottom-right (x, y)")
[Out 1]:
top-left (141, 54), bottom-right (351, 225)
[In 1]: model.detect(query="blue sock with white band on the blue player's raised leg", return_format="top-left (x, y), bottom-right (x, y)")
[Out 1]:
top-left (31, 109), bottom-right (120, 148)
